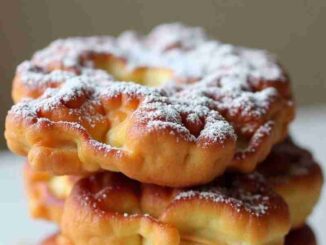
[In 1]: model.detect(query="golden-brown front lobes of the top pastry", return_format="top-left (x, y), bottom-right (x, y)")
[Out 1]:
top-left (6, 83), bottom-right (235, 186)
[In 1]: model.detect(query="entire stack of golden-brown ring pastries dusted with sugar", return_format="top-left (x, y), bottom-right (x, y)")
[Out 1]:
top-left (5, 23), bottom-right (323, 245)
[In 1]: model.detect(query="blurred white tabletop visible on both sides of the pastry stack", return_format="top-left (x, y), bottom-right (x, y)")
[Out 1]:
top-left (0, 107), bottom-right (326, 245)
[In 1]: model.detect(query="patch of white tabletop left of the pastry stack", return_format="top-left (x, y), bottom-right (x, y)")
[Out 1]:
top-left (0, 152), bottom-right (56, 245)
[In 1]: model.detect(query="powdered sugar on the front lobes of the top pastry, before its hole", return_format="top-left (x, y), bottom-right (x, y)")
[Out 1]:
top-left (10, 70), bottom-right (235, 145)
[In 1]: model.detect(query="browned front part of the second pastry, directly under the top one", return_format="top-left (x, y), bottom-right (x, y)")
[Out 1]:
top-left (57, 173), bottom-right (290, 245)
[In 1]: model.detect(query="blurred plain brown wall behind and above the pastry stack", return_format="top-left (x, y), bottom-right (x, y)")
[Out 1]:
top-left (0, 0), bottom-right (326, 149)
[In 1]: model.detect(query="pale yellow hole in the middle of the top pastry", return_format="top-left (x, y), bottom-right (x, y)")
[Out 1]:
top-left (93, 55), bottom-right (173, 87)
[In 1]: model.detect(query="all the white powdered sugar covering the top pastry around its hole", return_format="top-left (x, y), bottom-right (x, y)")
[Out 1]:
top-left (10, 23), bottom-right (292, 163)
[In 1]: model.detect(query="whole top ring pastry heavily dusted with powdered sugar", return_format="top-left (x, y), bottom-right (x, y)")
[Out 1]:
top-left (5, 24), bottom-right (294, 187)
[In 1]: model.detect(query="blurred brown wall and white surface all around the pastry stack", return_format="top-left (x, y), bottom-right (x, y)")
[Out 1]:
top-left (0, 0), bottom-right (326, 245)
